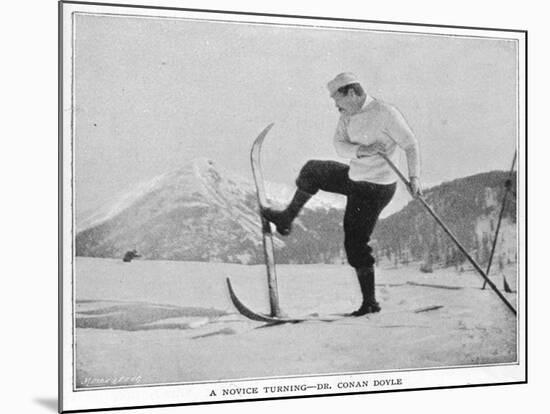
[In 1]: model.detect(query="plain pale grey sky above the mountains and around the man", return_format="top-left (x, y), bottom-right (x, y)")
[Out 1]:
top-left (74, 15), bottom-right (517, 217)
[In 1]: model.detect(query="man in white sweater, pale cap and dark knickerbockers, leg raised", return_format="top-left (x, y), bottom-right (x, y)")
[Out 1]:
top-left (262, 72), bottom-right (422, 316)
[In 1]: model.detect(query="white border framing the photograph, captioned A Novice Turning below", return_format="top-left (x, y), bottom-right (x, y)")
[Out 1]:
top-left (61, 2), bottom-right (526, 411)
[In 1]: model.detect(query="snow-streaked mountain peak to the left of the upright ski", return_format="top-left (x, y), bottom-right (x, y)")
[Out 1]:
top-left (77, 158), bottom-right (300, 263)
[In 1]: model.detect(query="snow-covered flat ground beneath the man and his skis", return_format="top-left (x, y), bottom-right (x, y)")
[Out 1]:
top-left (75, 257), bottom-right (517, 387)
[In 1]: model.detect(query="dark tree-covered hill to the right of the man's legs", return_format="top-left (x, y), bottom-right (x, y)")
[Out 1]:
top-left (373, 171), bottom-right (517, 266)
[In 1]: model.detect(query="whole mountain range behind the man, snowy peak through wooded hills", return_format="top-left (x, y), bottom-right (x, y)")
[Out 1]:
top-left (76, 159), bottom-right (515, 264)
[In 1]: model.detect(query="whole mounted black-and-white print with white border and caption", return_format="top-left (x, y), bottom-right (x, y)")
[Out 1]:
top-left (59, 1), bottom-right (527, 412)
